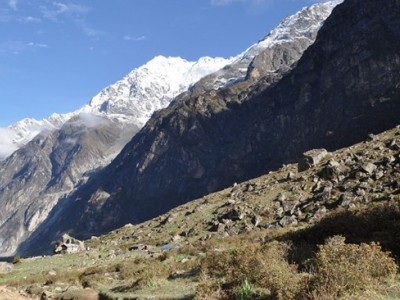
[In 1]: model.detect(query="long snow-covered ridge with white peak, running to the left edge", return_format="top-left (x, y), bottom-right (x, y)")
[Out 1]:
top-left (0, 56), bottom-right (232, 160)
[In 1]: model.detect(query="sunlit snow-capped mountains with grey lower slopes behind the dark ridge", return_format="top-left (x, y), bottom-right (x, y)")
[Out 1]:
top-left (0, 2), bottom-right (336, 255)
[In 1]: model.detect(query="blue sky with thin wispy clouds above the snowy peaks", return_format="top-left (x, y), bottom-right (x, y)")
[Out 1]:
top-left (0, 0), bottom-right (324, 127)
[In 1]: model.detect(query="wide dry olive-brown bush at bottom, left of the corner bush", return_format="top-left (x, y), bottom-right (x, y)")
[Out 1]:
top-left (197, 242), bottom-right (302, 299)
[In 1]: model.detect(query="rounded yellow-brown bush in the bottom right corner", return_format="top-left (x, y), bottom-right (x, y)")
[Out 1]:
top-left (311, 236), bottom-right (397, 299)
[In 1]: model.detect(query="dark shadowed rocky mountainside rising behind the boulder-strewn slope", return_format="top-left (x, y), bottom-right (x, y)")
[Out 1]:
top-left (21, 0), bottom-right (400, 254)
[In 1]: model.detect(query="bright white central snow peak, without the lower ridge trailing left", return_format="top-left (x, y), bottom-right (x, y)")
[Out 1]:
top-left (81, 56), bottom-right (232, 127)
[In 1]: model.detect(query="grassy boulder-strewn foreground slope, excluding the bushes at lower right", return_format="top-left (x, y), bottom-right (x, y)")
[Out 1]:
top-left (0, 121), bottom-right (400, 300)
